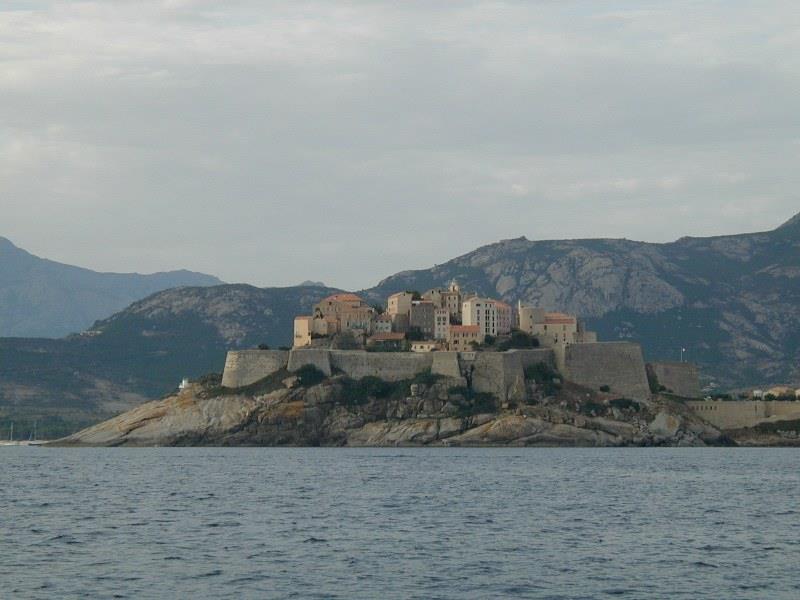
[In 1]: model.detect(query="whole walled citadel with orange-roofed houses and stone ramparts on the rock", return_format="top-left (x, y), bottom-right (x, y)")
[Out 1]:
top-left (216, 281), bottom-right (800, 429)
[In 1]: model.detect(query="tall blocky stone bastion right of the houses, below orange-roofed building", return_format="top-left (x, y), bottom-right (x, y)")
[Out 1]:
top-left (562, 342), bottom-right (650, 400)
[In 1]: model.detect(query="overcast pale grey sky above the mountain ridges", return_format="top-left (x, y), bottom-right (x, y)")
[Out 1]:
top-left (0, 0), bottom-right (800, 289)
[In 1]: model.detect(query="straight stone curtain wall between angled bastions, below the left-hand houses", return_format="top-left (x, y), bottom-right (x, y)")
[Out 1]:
top-left (331, 350), bottom-right (434, 381)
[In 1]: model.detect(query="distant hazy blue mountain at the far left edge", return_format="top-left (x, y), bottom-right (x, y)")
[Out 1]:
top-left (0, 237), bottom-right (222, 337)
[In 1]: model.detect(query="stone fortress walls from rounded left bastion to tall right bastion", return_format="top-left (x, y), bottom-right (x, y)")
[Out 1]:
top-left (222, 343), bottom-right (649, 401)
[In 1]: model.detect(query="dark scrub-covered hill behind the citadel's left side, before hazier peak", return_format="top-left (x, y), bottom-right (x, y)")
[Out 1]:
top-left (0, 285), bottom-right (339, 437)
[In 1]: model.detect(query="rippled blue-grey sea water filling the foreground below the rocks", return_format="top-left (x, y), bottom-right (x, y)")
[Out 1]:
top-left (0, 448), bottom-right (800, 599)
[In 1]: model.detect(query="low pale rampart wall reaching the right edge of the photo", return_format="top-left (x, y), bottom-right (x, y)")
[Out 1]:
top-left (686, 400), bottom-right (800, 429)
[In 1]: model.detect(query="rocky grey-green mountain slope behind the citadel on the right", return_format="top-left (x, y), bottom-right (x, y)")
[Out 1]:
top-left (368, 215), bottom-right (800, 387)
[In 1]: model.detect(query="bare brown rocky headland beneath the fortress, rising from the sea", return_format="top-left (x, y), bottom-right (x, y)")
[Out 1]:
top-left (58, 377), bottom-right (726, 446)
